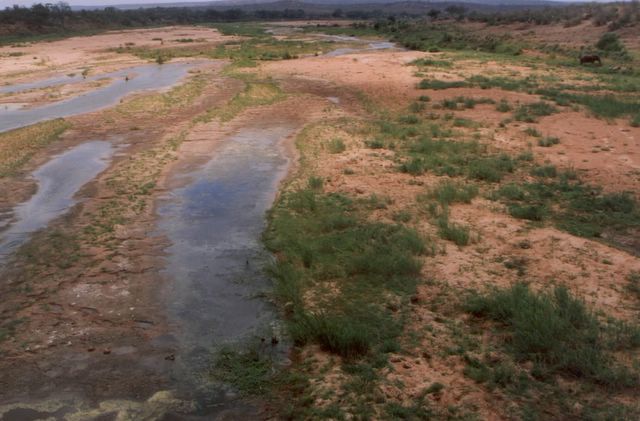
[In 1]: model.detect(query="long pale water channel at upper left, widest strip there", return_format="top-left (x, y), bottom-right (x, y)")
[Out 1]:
top-left (0, 63), bottom-right (193, 132)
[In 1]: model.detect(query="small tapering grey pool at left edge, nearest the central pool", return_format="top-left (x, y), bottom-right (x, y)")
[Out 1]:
top-left (0, 140), bottom-right (114, 262)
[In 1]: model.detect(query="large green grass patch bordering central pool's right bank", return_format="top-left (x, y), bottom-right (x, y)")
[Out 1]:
top-left (265, 188), bottom-right (427, 359)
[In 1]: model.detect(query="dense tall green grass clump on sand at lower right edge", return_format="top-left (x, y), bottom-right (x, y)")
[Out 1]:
top-left (465, 283), bottom-right (640, 388)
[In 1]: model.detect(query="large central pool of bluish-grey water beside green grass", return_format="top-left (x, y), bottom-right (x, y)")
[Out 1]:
top-left (158, 126), bottom-right (293, 406)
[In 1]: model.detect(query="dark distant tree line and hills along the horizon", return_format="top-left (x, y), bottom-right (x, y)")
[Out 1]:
top-left (0, 0), bottom-right (640, 41)
